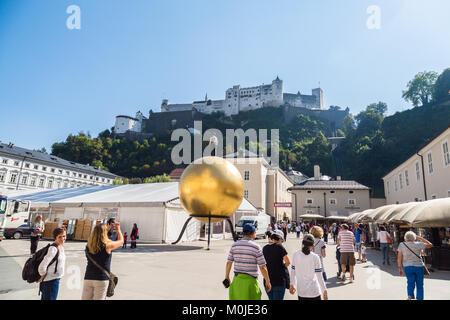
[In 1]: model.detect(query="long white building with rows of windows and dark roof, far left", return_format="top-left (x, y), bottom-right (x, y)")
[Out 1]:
top-left (0, 142), bottom-right (119, 192)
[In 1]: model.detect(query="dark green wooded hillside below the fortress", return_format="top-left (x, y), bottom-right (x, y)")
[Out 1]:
top-left (52, 68), bottom-right (450, 197)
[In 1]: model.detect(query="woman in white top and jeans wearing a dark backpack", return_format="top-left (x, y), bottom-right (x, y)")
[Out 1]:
top-left (37, 228), bottom-right (66, 300)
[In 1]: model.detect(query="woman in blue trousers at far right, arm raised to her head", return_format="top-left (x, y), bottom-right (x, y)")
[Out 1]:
top-left (397, 231), bottom-right (433, 300)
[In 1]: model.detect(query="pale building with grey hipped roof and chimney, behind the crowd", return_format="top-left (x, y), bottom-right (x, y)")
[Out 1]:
top-left (288, 166), bottom-right (371, 220)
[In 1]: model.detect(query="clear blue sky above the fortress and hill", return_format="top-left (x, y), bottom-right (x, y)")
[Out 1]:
top-left (0, 0), bottom-right (450, 151)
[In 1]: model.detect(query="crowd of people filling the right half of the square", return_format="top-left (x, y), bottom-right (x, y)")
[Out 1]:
top-left (225, 221), bottom-right (432, 300)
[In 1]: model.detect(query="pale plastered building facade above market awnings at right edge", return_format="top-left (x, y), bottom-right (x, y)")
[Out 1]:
top-left (383, 126), bottom-right (450, 204)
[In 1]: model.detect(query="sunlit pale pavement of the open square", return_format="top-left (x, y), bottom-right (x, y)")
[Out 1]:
top-left (0, 234), bottom-right (450, 300)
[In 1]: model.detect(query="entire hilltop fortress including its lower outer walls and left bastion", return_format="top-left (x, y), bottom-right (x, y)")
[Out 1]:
top-left (113, 76), bottom-right (349, 139)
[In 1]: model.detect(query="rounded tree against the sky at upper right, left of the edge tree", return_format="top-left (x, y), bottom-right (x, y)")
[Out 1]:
top-left (402, 71), bottom-right (438, 107)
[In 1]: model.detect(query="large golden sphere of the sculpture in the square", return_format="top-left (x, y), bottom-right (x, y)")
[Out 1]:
top-left (178, 157), bottom-right (244, 222)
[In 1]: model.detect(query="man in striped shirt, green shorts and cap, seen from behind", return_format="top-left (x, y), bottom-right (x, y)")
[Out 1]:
top-left (225, 223), bottom-right (272, 300)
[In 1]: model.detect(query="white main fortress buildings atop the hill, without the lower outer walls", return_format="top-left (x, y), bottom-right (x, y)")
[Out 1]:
top-left (161, 77), bottom-right (323, 116)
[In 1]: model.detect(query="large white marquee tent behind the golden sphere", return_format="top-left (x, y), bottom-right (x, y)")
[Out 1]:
top-left (8, 182), bottom-right (258, 243)
